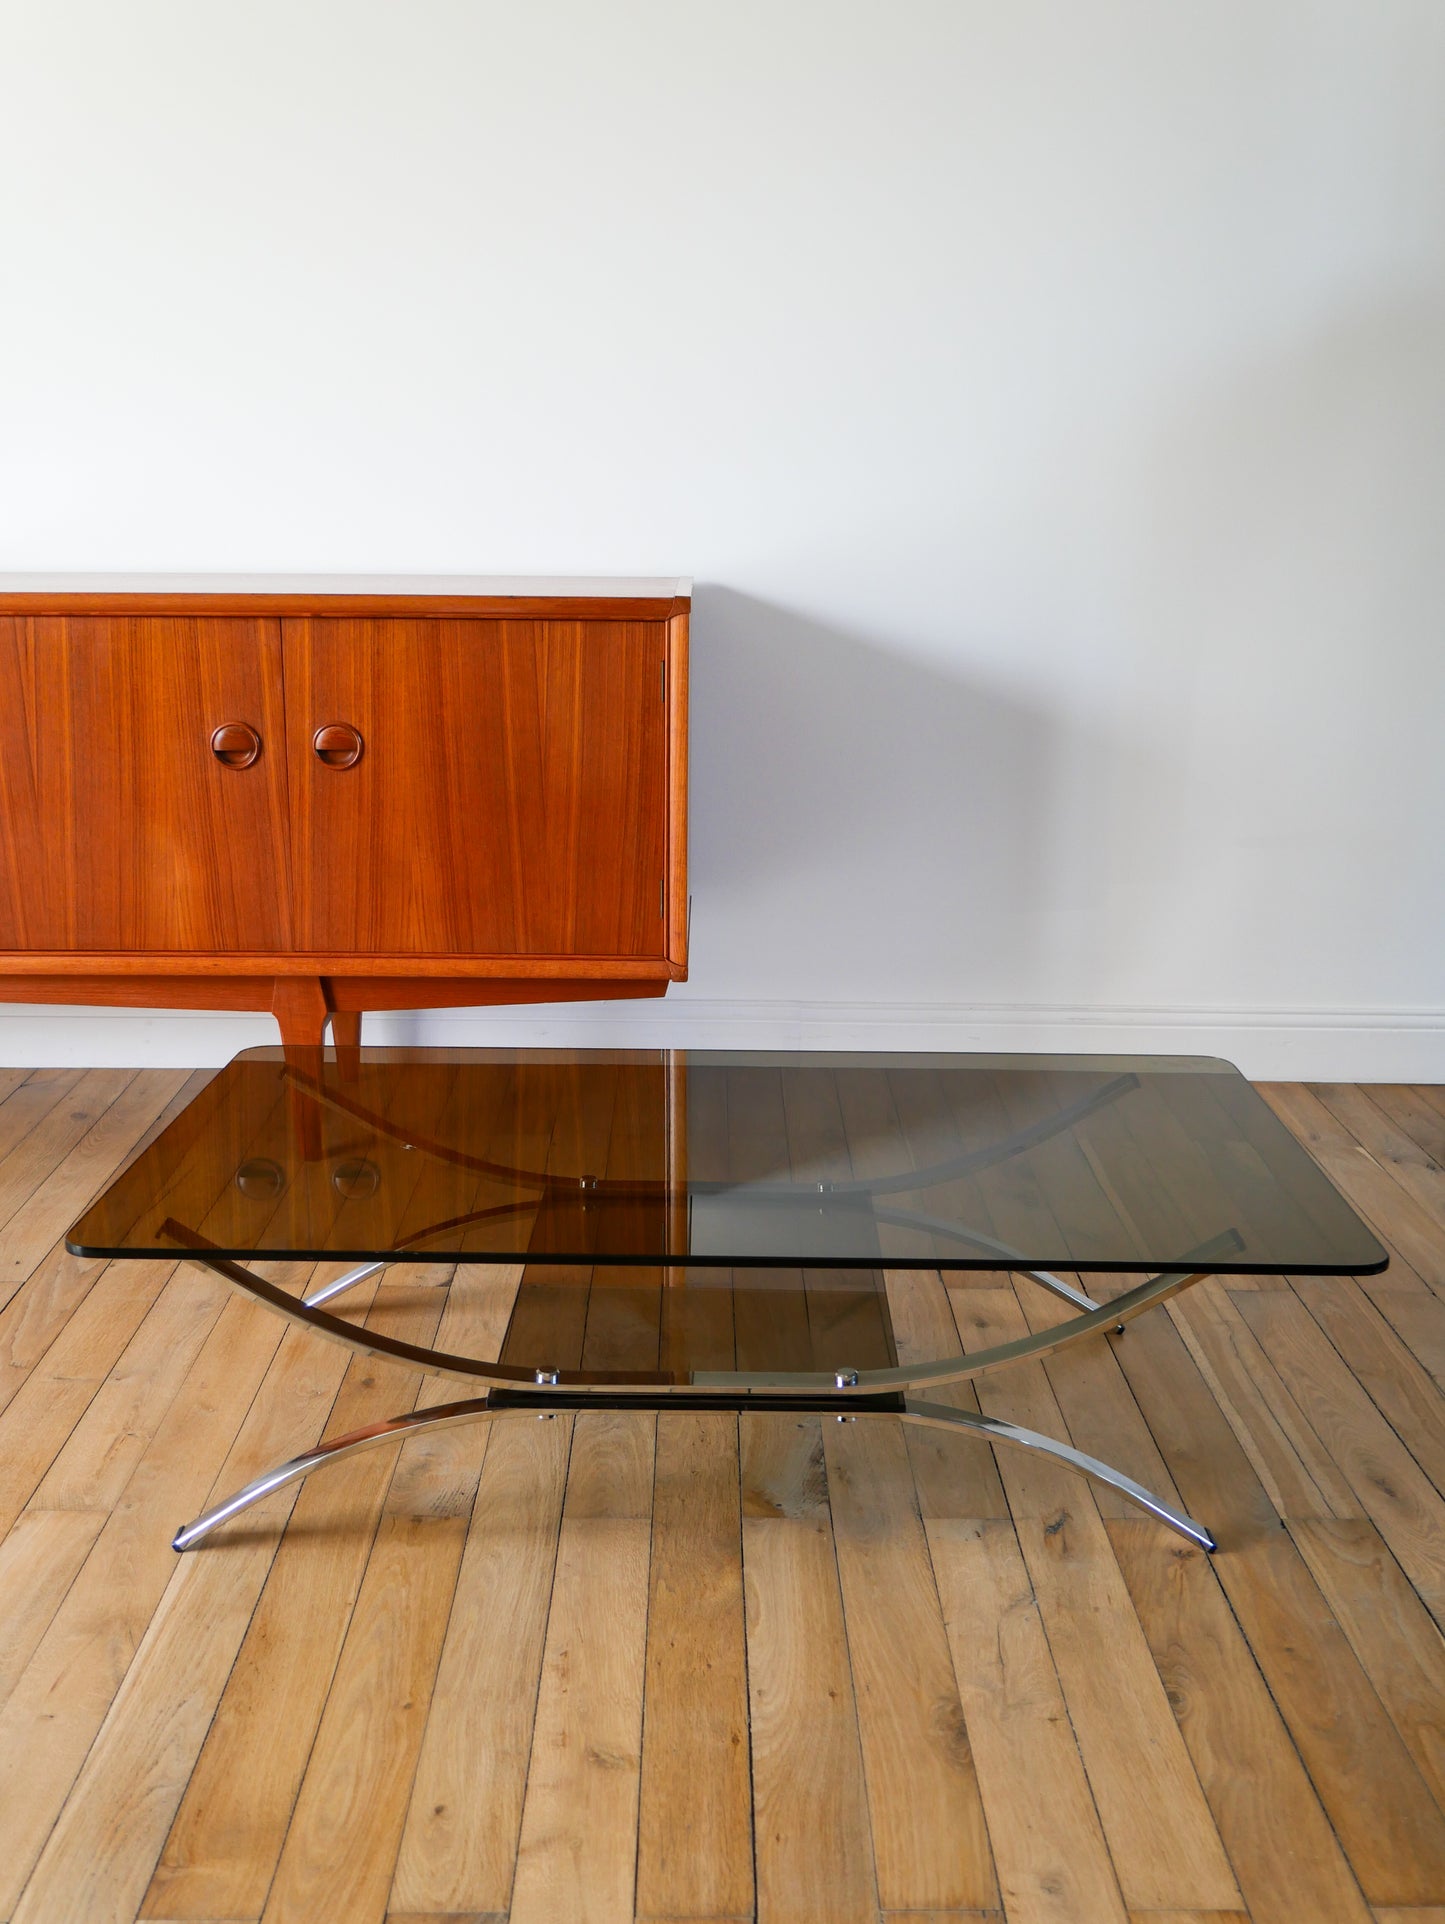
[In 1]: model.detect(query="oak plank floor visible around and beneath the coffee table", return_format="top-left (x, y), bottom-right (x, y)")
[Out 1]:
top-left (0, 1070), bottom-right (1445, 1924)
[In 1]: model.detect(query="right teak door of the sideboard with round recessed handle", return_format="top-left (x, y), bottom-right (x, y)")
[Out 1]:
top-left (283, 616), bottom-right (668, 956)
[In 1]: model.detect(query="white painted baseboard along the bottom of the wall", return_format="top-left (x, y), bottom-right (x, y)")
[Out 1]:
top-left (0, 995), bottom-right (1445, 1083)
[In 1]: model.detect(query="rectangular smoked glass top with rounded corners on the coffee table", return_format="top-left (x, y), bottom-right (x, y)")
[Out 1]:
top-left (69, 1049), bottom-right (1385, 1276)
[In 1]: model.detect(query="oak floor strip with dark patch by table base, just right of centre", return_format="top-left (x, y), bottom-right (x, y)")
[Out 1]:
top-left (741, 1414), bottom-right (879, 1924)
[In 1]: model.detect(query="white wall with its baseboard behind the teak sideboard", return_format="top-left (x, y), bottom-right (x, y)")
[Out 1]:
top-left (0, 0), bottom-right (1445, 1079)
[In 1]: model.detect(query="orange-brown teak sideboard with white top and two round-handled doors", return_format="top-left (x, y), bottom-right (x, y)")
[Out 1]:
top-left (0, 575), bottom-right (689, 1049)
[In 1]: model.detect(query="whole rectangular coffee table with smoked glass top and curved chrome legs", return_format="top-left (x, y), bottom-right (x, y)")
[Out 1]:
top-left (67, 1049), bottom-right (1387, 1551)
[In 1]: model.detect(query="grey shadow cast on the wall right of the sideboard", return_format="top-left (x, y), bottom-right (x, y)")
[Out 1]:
top-left (691, 585), bottom-right (1106, 1000)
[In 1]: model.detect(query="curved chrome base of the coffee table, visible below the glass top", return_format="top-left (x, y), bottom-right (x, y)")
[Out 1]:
top-left (165, 1222), bottom-right (1233, 1551)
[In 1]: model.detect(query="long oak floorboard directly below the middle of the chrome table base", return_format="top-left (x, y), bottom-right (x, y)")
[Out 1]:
top-left (635, 1410), bottom-right (752, 1918)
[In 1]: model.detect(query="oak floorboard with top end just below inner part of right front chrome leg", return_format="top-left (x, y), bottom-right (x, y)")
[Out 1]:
top-left (927, 1518), bottom-right (1124, 1924)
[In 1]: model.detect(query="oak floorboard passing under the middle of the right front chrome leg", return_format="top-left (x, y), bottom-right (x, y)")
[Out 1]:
top-left (952, 1289), bottom-right (1239, 1909)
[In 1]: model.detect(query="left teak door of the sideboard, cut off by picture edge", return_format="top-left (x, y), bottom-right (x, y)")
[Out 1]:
top-left (0, 616), bottom-right (292, 952)
